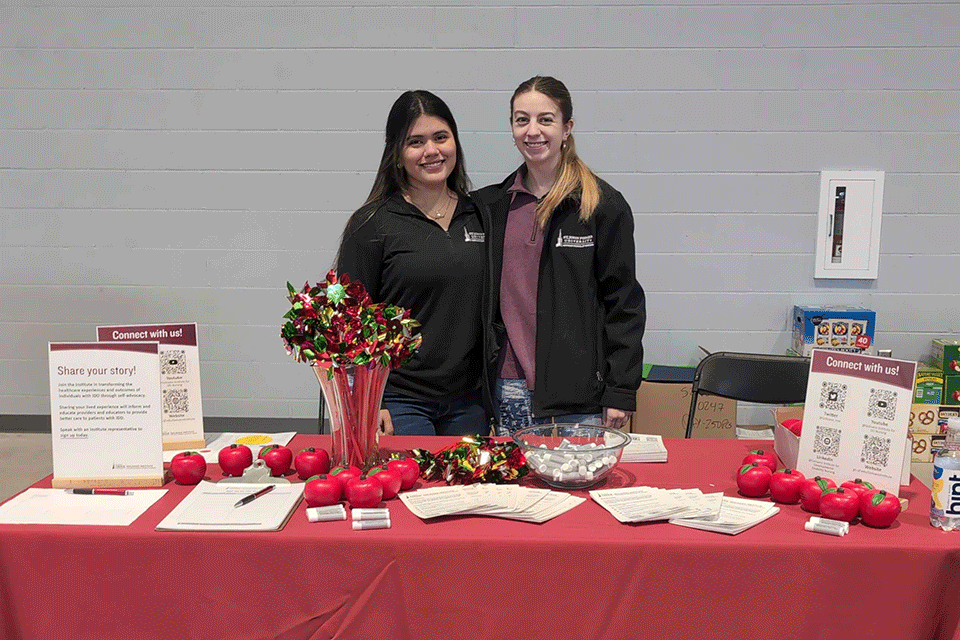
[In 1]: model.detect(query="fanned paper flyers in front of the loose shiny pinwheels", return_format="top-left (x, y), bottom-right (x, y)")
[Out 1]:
top-left (399, 484), bottom-right (584, 523)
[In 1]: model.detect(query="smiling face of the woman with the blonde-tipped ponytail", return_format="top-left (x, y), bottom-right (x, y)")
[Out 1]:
top-left (510, 91), bottom-right (573, 169)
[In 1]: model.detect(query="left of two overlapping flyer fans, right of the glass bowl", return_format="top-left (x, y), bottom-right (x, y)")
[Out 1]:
top-left (590, 487), bottom-right (723, 522)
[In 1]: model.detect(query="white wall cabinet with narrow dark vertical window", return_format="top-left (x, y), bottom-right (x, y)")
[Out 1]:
top-left (814, 171), bottom-right (883, 279)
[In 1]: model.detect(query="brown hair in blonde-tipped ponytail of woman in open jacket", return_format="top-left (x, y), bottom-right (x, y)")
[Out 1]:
top-left (510, 76), bottom-right (600, 229)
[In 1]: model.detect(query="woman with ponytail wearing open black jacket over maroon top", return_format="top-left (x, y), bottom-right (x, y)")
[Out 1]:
top-left (475, 76), bottom-right (646, 435)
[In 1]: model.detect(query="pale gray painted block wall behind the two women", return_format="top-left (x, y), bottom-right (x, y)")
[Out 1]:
top-left (0, 0), bottom-right (960, 418)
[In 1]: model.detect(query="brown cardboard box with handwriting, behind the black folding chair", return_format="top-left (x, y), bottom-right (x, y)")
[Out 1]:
top-left (630, 365), bottom-right (737, 438)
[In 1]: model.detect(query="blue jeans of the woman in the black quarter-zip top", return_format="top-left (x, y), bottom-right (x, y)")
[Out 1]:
top-left (383, 390), bottom-right (490, 436)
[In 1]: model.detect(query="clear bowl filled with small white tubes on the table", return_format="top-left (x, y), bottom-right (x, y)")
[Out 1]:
top-left (513, 423), bottom-right (630, 489)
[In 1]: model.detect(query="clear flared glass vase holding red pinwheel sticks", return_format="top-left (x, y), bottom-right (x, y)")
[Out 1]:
top-left (313, 364), bottom-right (390, 470)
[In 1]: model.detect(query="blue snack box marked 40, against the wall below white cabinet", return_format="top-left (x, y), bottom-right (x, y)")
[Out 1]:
top-left (791, 305), bottom-right (877, 357)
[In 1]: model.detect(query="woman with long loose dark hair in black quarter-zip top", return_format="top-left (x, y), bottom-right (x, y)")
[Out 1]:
top-left (337, 90), bottom-right (489, 435)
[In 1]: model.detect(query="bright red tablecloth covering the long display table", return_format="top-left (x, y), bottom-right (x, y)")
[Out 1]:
top-left (0, 436), bottom-right (960, 640)
